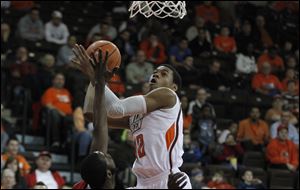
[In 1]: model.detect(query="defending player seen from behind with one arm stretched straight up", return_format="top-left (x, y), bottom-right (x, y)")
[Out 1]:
top-left (73, 50), bottom-right (115, 189)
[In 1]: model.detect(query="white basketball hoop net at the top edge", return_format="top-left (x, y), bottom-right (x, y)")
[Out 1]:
top-left (128, 1), bottom-right (186, 19)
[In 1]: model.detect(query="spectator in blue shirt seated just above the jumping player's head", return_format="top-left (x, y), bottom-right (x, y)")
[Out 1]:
top-left (169, 38), bottom-right (192, 67)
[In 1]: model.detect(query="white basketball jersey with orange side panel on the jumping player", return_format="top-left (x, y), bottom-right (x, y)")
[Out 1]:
top-left (129, 88), bottom-right (183, 179)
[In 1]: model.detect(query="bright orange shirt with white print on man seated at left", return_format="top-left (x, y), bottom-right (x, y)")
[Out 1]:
top-left (42, 87), bottom-right (73, 114)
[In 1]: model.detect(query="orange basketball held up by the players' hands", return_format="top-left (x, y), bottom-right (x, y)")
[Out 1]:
top-left (86, 40), bottom-right (121, 72)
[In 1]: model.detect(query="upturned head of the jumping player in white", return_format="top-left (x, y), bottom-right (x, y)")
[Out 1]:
top-left (150, 64), bottom-right (181, 91)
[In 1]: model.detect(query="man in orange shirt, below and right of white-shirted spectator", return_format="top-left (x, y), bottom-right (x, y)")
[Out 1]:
top-left (252, 62), bottom-right (282, 96)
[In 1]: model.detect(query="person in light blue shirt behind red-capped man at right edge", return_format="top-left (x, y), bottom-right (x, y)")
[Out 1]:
top-left (270, 111), bottom-right (299, 146)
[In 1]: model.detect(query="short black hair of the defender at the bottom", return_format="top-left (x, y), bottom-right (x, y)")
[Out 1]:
top-left (80, 152), bottom-right (107, 189)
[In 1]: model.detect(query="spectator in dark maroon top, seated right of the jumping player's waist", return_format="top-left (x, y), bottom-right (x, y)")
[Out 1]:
top-left (216, 131), bottom-right (244, 170)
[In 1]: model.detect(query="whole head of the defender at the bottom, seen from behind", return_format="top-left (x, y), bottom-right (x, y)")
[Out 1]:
top-left (80, 151), bottom-right (116, 189)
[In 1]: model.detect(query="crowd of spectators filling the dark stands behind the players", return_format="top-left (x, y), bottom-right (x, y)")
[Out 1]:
top-left (1, 1), bottom-right (299, 189)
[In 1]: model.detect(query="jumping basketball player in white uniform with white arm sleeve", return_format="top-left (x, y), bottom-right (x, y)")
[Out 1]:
top-left (72, 45), bottom-right (191, 189)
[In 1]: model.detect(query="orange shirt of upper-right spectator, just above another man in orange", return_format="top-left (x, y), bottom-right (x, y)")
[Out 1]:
top-left (258, 53), bottom-right (284, 70)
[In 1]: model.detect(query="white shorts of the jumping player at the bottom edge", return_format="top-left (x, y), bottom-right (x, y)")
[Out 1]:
top-left (127, 169), bottom-right (192, 189)
